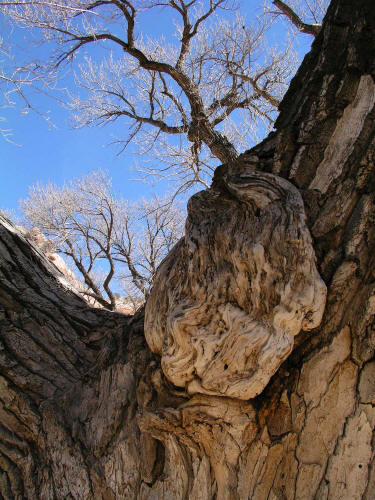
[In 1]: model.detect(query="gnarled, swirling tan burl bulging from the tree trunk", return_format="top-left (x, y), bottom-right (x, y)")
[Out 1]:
top-left (145, 168), bottom-right (326, 399)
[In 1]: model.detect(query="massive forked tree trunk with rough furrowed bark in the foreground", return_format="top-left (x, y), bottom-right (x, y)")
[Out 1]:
top-left (0, 0), bottom-right (375, 500)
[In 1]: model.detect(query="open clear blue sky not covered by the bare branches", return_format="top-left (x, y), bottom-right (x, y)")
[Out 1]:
top-left (0, 0), bottom-right (311, 215)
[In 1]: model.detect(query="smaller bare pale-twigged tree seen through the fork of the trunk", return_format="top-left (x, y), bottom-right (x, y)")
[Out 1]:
top-left (21, 171), bottom-right (183, 310)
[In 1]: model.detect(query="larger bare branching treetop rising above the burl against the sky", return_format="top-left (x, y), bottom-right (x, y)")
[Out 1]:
top-left (0, 0), bottom-right (323, 192)
